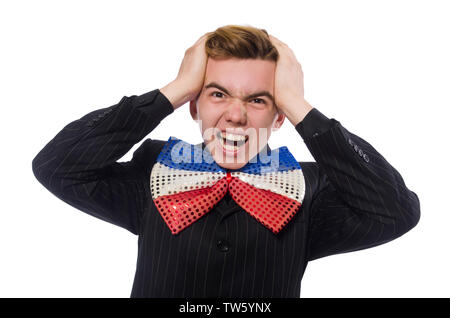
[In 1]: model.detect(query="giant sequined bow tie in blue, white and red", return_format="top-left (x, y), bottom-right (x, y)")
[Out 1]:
top-left (150, 137), bottom-right (305, 234)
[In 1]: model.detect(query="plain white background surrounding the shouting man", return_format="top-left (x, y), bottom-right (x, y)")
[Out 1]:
top-left (0, 0), bottom-right (450, 297)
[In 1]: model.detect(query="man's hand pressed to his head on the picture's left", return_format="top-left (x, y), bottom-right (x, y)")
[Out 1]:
top-left (160, 32), bottom-right (211, 109)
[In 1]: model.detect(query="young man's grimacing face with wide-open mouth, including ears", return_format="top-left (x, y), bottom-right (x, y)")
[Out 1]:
top-left (190, 58), bottom-right (285, 169)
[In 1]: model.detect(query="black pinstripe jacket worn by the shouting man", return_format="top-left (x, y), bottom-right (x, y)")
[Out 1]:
top-left (32, 89), bottom-right (420, 297)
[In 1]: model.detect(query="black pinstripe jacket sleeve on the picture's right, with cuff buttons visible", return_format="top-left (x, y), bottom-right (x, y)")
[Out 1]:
top-left (295, 108), bottom-right (420, 260)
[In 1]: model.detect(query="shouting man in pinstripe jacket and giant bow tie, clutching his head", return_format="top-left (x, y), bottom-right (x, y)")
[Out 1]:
top-left (33, 25), bottom-right (420, 297)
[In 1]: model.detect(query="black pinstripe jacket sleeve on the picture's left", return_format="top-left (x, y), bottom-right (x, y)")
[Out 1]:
top-left (32, 89), bottom-right (174, 234)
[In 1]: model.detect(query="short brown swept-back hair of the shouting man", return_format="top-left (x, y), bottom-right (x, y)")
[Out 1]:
top-left (205, 24), bottom-right (278, 62)
